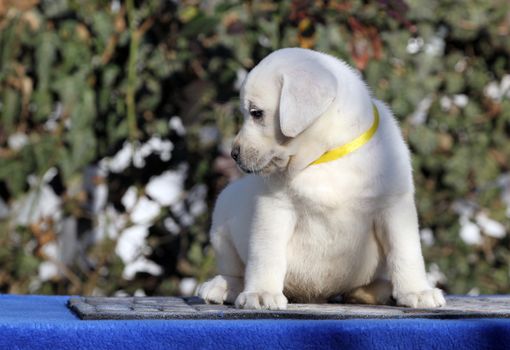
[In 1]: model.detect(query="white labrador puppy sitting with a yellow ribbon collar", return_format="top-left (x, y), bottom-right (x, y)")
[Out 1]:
top-left (198, 48), bottom-right (445, 309)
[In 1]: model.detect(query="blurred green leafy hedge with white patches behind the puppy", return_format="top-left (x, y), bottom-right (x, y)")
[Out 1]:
top-left (0, 0), bottom-right (510, 295)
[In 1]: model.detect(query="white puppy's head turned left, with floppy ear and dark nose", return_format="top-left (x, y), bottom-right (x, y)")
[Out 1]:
top-left (232, 49), bottom-right (337, 175)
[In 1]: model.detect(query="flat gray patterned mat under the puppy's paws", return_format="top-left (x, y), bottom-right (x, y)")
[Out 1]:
top-left (68, 296), bottom-right (510, 320)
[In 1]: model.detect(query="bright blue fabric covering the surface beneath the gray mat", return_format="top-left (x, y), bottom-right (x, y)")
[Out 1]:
top-left (0, 295), bottom-right (510, 350)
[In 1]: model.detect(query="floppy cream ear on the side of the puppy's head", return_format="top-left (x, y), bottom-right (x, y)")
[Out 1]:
top-left (280, 62), bottom-right (337, 137)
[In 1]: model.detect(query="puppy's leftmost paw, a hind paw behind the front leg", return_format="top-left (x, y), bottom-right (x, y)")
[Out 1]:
top-left (196, 275), bottom-right (243, 304)
